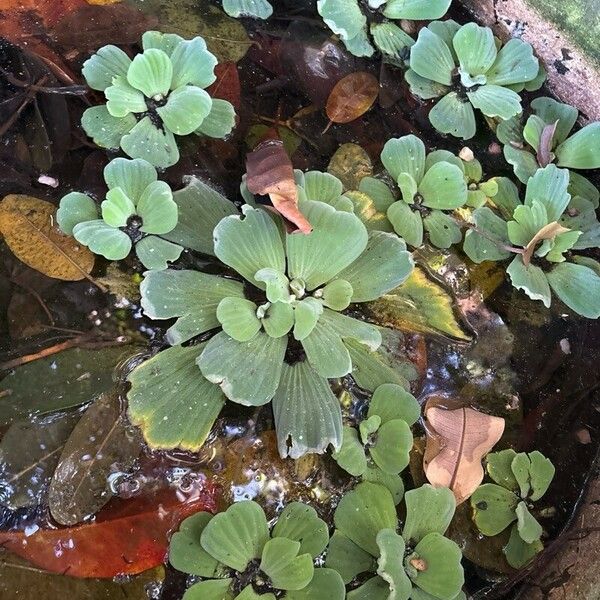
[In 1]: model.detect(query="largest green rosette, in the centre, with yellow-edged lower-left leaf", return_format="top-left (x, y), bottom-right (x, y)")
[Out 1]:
top-left (128, 195), bottom-right (414, 458)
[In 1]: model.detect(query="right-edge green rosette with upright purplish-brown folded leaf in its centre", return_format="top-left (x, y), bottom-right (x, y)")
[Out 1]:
top-left (496, 97), bottom-right (600, 199)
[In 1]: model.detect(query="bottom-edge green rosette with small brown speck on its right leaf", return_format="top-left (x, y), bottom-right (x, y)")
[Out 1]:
top-left (325, 482), bottom-right (465, 600)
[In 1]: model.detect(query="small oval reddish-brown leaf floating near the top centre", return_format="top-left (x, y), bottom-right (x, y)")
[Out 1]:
top-left (325, 71), bottom-right (379, 128)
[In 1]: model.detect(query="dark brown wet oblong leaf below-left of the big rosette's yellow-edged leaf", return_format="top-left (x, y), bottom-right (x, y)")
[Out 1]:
top-left (48, 391), bottom-right (142, 525)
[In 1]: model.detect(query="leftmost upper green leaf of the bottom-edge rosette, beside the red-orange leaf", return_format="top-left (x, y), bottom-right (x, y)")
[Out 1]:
top-left (169, 512), bottom-right (219, 577)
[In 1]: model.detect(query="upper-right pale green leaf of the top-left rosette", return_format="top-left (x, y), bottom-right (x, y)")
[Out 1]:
top-left (171, 36), bottom-right (217, 90)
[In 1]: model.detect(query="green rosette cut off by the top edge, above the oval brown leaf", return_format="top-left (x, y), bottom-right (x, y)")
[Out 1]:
top-left (317, 0), bottom-right (452, 66)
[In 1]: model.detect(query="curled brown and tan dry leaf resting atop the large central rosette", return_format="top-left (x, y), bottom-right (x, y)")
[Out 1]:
top-left (246, 138), bottom-right (312, 233)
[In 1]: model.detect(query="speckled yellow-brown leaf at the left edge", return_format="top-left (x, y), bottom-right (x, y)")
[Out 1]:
top-left (0, 194), bottom-right (94, 281)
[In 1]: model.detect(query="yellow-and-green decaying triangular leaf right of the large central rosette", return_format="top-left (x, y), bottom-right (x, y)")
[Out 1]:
top-left (366, 267), bottom-right (471, 341)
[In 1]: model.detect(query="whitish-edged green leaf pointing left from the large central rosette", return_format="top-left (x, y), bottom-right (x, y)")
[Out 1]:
top-left (140, 270), bottom-right (244, 346)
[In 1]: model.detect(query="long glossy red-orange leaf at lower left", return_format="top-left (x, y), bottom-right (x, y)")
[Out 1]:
top-left (0, 484), bottom-right (217, 578)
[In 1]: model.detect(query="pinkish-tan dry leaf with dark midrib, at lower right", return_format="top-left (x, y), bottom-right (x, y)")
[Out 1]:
top-left (423, 406), bottom-right (504, 504)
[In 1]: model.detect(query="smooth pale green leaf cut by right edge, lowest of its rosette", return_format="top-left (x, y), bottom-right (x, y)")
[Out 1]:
top-left (547, 262), bottom-right (600, 319)
